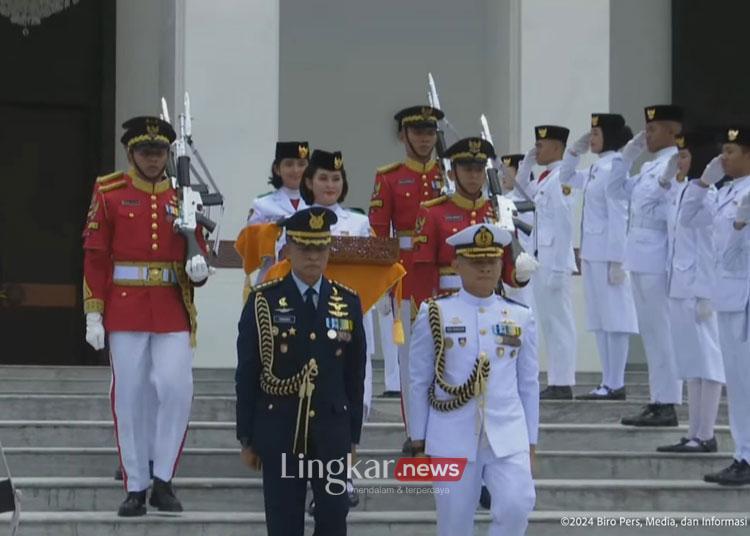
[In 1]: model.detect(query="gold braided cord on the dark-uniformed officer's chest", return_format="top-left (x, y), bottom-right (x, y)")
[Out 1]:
top-left (255, 292), bottom-right (318, 454)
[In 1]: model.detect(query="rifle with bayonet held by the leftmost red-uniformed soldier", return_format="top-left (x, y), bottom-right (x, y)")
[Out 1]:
top-left (172, 92), bottom-right (224, 259)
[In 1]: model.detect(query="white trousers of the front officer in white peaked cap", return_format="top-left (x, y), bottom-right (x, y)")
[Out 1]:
top-left (433, 433), bottom-right (536, 536)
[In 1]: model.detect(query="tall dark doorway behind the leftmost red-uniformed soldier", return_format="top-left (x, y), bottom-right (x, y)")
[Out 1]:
top-left (0, 0), bottom-right (115, 365)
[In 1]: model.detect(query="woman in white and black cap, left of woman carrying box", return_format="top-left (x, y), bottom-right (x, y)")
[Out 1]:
top-left (247, 141), bottom-right (310, 284)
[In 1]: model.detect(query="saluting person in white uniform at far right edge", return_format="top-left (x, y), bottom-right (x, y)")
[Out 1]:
top-left (680, 126), bottom-right (750, 485)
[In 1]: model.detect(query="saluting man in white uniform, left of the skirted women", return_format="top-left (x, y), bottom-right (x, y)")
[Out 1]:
top-left (516, 125), bottom-right (576, 400)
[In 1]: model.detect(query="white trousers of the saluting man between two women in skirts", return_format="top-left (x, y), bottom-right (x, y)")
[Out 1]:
top-left (630, 272), bottom-right (682, 404)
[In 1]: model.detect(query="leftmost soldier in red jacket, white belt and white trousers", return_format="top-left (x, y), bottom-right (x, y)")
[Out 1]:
top-left (83, 117), bottom-right (209, 516)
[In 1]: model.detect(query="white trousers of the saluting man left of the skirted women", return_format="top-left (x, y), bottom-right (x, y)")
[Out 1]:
top-left (531, 266), bottom-right (576, 386)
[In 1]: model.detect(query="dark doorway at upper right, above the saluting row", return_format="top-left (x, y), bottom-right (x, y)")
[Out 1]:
top-left (672, 0), bottom-right (750, 127)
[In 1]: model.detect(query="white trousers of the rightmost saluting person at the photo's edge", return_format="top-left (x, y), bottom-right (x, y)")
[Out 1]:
top-left (718, 311), bottom-right (750, 462)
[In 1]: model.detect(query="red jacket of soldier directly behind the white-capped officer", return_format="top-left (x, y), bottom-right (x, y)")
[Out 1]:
top-left (412, 193), bottom-right (525, 305)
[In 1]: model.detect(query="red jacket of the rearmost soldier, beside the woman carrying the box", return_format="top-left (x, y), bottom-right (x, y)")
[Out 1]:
top-left (370, 159), bottom-right (443, 298)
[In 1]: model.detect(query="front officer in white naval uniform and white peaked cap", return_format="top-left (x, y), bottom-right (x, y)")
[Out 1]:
top-left (409, 223), bottom-right (539, 536)
